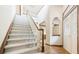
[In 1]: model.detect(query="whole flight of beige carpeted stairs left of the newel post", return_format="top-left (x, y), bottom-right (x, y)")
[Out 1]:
top-left (5, 15), bottom-right (38, 54)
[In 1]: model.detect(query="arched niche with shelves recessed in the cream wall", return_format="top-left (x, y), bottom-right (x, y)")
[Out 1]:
top-left (52, 17), bottom-right (60, 36)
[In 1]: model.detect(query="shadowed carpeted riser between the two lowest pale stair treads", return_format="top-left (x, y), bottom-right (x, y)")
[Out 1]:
top-left (5, 44), bottom-right (37, 52)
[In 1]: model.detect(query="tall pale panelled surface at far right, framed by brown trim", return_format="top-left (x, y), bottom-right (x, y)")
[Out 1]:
top-left (63, 9), bottom-right (77, 53)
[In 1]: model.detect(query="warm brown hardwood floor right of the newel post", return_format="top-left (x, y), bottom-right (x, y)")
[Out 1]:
top-left (45, 45), bottom-right (69, 54)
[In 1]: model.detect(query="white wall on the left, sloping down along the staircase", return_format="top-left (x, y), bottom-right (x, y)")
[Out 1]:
top-left (0, 5), bottom-right (16, 47)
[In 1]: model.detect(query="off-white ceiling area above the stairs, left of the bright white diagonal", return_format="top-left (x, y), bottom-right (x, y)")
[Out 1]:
top-left (24, 5), bottom-right (43, 16)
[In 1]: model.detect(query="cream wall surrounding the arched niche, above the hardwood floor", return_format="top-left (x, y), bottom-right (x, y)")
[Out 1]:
top-left (47, 5), bottom-right (63, 45)
